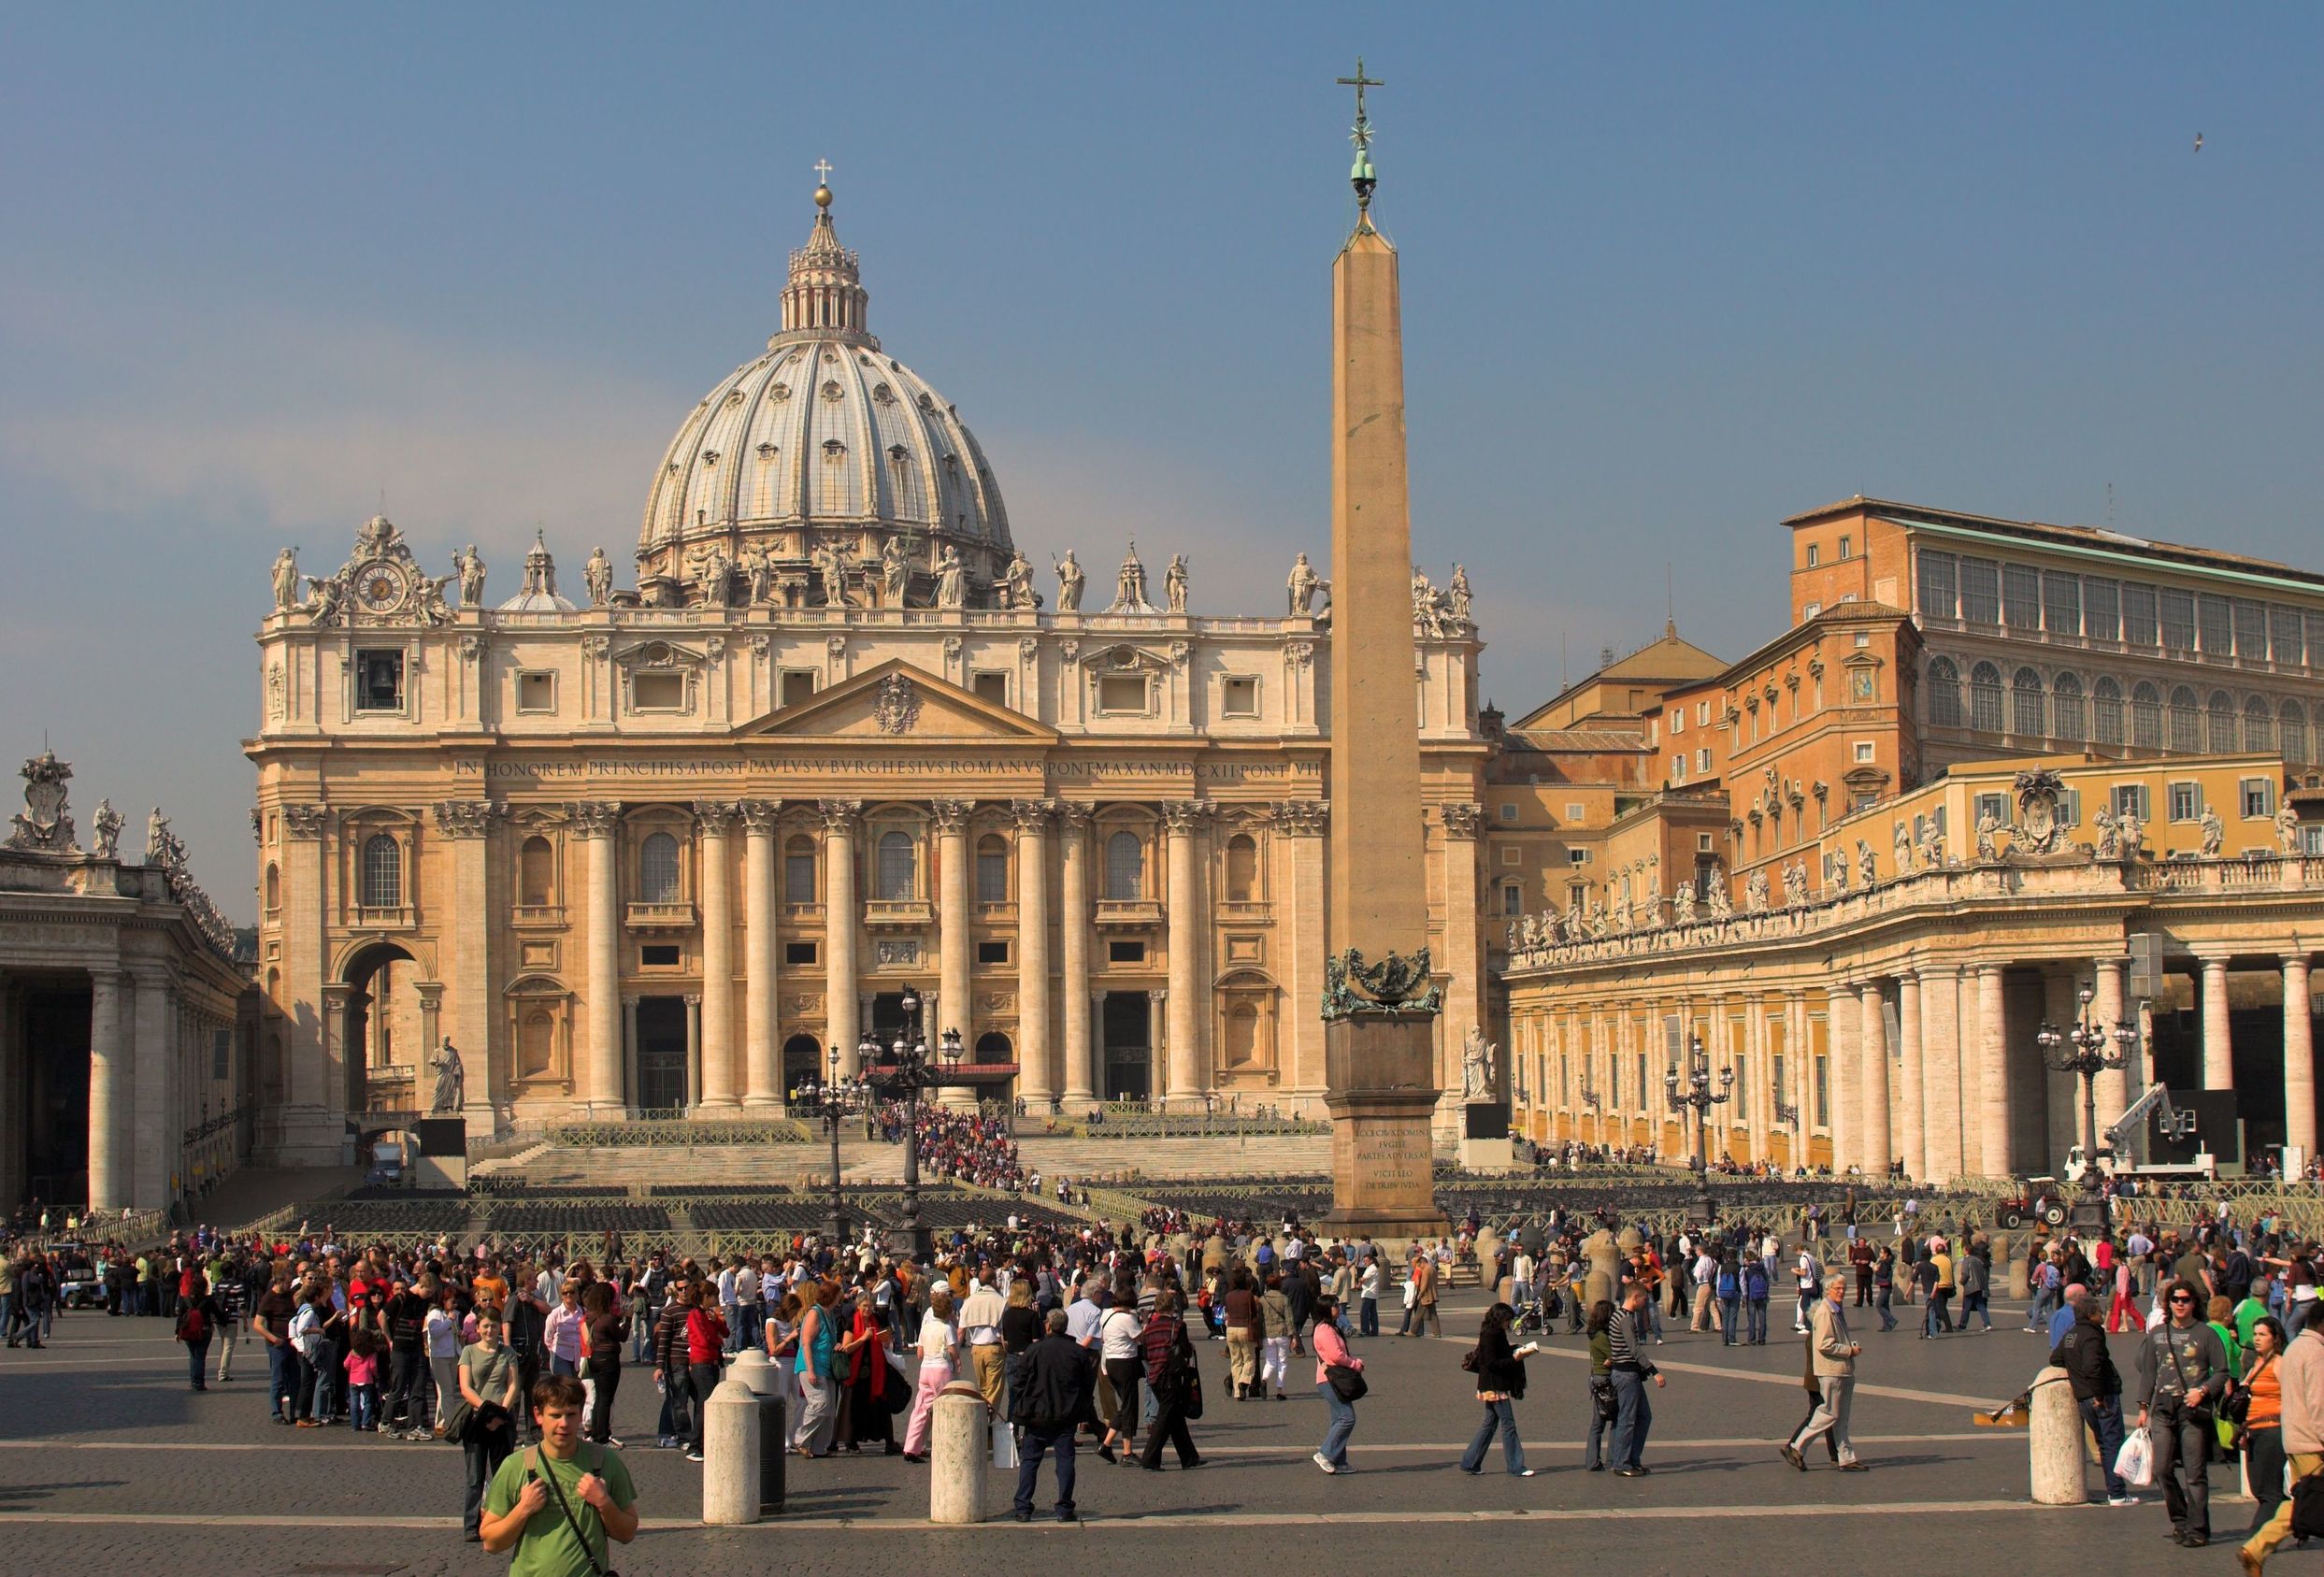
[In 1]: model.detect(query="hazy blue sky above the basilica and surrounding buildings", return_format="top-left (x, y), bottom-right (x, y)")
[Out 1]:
top-left (0, 5), bottom-right (2324, 917)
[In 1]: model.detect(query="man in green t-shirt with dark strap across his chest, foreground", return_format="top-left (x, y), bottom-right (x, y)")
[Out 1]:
top-left (479, 1375), bottom-right (637, 1577)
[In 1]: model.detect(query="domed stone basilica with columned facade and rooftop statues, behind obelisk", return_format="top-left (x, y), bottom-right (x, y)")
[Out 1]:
top-left (247, 188), bottom-right (1490, 1161)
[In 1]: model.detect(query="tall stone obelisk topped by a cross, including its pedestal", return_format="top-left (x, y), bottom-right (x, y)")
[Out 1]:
top-left (1323, 61), bottom-right (1443, 1238)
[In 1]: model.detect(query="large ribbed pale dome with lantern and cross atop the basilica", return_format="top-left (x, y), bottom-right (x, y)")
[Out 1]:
top-left (637, 186), bottom-right (1013, 601)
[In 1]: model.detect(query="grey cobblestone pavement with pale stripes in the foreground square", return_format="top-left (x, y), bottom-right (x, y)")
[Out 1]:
top-left (0, 1296), bottom-right (2249, 1577)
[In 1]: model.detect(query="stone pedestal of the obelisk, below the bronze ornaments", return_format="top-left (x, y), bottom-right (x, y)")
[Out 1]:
top-left (1323, 1012), bottom-right (1445, 1238)
